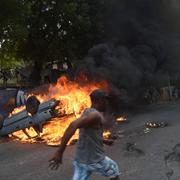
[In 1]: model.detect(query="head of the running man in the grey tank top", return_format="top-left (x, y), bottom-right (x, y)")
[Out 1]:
top-left (90, 89), bottom-right (109, 112)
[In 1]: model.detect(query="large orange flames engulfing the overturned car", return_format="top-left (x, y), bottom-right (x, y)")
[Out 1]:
top-left (11, 76), bottom-right (108, 145)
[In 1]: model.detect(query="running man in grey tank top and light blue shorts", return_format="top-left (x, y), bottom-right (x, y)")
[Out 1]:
top-left (50, 89), bottom-right (120, 180)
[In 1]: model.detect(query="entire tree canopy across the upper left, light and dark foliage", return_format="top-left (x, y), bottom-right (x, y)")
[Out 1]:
top-left (0, 0), bottom-right (107, 66)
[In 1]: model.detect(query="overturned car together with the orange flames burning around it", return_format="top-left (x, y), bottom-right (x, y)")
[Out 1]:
top-left (0, 77), bottom-right (125, 146)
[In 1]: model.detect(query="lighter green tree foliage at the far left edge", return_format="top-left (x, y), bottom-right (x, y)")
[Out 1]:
top-left (0, 0), bottom-right (27, 68)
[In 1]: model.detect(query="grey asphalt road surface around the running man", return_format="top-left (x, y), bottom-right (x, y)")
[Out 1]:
top-left (0, 103), bottom-right (180, 180)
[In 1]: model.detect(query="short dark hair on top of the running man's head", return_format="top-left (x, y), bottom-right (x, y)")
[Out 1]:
top-left (90, 89), bottom-right (109, 102)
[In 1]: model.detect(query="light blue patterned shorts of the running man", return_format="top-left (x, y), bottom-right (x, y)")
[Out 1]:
top-left (73, 156), bottom-right (120, 180)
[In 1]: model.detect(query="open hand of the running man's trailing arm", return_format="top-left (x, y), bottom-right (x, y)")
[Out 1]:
top-left (49, 151), bottom-right (62, 170)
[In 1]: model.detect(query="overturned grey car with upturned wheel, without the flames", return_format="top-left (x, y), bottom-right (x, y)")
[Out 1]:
top-left (0, 96), bottom-right (59, 137)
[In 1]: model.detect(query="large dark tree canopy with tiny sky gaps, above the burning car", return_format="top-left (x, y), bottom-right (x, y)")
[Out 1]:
top-left (17, 0), bottom-right (103, 64)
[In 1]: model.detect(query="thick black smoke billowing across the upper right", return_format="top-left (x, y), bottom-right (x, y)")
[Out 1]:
top-left (77, 0), bottom-right (180, 107)
